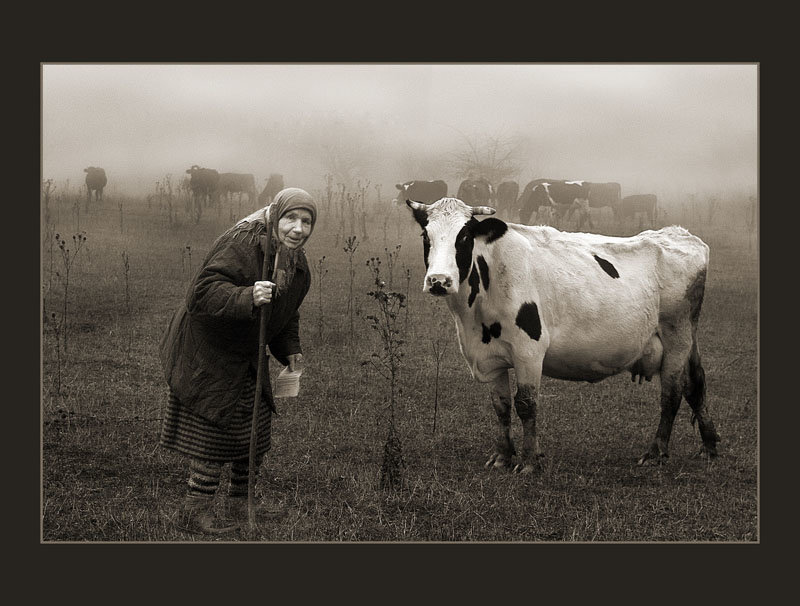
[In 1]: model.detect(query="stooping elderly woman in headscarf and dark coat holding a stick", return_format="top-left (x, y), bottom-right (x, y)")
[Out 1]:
top-left (160, 187), bottom-right (317, 533)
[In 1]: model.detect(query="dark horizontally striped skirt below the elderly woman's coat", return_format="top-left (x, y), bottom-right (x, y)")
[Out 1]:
top-left (159, 380), bottom-right (272, 463)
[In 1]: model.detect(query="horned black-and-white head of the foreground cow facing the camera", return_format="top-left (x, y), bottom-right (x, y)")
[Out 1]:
top-left (406, 198), bottom-right (500, 296)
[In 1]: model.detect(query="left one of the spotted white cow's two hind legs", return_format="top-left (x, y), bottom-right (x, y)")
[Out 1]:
top-left (639, 318), bottom-right (692, 465)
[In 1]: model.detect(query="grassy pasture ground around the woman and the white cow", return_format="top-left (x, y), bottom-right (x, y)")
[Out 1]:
top-left (41, 184), bottom-right (759, 542)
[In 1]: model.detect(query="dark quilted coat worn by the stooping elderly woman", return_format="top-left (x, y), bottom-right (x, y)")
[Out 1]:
top-left (160, 222), bottom-right (311, 427)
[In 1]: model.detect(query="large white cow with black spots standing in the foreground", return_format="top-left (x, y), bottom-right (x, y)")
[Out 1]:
top-left (407, 198), bottom-right (719, 473)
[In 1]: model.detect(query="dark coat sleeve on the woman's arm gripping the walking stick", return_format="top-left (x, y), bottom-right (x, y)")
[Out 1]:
top-left (187, 242), bottom-right (258, 320)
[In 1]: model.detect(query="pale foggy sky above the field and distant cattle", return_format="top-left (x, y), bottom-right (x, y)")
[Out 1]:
top-left (41, 63), bottom-right (758, 201)
